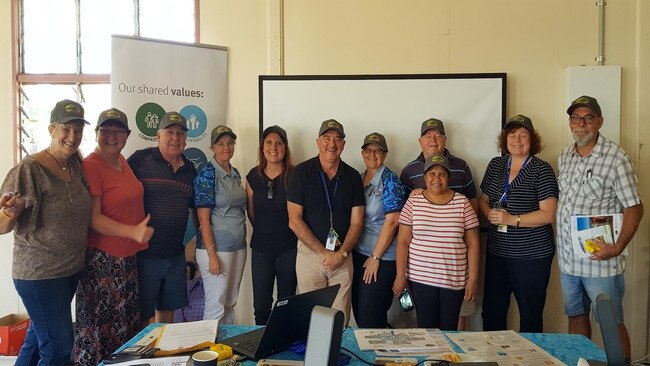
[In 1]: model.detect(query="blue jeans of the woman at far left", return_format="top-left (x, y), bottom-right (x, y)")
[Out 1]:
top-left (14, 273), bottom-right (80, 366)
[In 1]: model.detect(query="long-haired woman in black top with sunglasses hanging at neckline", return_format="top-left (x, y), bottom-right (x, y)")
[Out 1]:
top-left (246, 126), bottom-right (298, 325)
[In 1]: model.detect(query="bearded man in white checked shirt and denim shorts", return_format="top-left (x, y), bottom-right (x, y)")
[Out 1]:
top-left (557, 95), bottom-right (643, 359)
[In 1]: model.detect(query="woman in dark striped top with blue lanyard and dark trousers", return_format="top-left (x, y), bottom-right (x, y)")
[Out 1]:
top-left (479, 115), bottom-right (558, 333)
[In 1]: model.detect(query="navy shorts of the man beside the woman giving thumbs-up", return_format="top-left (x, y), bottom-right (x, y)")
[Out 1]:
top-left (138, 253), bottom-right (187, 321)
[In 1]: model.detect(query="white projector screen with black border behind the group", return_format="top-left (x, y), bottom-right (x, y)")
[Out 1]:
top-left (259, 73), bottom-right (506, 189)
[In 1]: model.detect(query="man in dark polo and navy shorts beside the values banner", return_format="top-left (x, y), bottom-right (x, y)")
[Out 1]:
top-left (128, 112), bottom-right (196, 324)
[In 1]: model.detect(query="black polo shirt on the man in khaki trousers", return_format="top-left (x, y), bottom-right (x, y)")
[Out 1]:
top-left (287, 156), bottom-right (365, 243)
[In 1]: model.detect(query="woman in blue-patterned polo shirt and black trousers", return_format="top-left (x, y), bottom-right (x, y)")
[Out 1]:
top-left (352, 132), bottom-right (406, 328)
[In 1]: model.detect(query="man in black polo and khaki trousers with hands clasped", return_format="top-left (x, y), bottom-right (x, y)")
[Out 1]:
top-left (287, 119), bottom-right (365, 325)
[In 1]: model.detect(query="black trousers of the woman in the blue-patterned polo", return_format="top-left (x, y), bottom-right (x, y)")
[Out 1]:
top-left (352, 251), bottom-right (397, 328)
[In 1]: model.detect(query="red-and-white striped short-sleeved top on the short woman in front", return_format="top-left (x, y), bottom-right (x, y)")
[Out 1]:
top-left (399, 193), bottom-right (479, 290)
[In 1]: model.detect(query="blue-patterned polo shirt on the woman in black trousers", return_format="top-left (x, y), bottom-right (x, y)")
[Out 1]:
top-left (354, 166), bottom-right (406, 261)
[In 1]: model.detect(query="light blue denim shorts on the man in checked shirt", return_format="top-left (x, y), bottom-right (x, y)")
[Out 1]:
top-left (560, 272), bottom-right (625, 324)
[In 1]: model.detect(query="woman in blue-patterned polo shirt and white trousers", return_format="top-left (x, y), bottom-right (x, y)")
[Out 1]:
top-left (194, 126), bottom-right (246, 324)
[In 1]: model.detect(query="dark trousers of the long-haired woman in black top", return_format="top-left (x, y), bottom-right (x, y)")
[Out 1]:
top-left (251, 247), bottom-right (297, 325)
